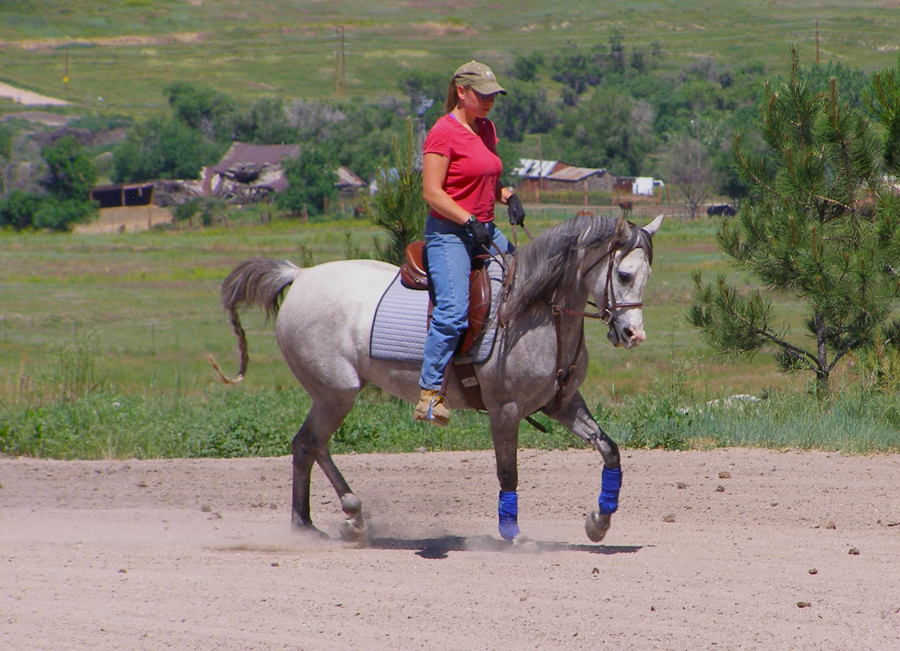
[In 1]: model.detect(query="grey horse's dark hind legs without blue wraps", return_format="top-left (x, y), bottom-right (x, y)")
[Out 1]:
top-left (291, 391), bottom-right (365, 540)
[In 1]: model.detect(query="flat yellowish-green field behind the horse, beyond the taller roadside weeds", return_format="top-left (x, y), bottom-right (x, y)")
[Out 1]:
top-left (0, 206), bottom-right (805, 402)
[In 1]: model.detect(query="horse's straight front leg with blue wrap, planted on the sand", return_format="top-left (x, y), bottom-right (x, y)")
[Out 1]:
top-left (490, 403), bottom-right (528, 545)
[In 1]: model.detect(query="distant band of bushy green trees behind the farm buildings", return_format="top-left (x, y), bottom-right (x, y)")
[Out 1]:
top-left (0, 37), bottom-right (892, 227)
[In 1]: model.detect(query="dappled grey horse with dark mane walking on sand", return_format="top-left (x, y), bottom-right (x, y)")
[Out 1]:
top-left (219, 215), bottom-right (664, 545)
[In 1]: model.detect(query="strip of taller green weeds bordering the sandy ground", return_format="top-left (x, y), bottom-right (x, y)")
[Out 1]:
top-left (0, 374), bottom-right (900, 459)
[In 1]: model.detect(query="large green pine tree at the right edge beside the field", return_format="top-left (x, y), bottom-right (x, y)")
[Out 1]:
top-left (688, 50), bottom-right (900, 388)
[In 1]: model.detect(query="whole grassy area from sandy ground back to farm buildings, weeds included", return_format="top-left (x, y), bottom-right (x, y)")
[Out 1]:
top-left (0, 205), bottom-right (900, 458)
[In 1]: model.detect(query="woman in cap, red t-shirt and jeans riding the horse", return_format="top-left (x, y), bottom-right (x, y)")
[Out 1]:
top-left (414, 61), bottom-right (525, 425)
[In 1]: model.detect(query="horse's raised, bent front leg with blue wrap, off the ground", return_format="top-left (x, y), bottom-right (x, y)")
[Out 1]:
top-left (544, 392), bottom-right (622, 542)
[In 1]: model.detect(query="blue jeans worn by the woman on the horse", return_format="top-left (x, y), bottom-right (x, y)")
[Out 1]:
top-left (419, 215), bottom-right (513, 390)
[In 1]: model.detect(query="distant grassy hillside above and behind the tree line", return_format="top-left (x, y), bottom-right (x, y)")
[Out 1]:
top-left (0, 0), bottom-right (900, 115)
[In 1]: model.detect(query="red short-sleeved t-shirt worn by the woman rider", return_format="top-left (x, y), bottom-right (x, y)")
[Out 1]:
top-left (423, 113), bottom-right (503, 222)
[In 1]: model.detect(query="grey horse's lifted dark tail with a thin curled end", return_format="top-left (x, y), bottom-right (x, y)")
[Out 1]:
top-left (208, 258), bottom-right (300, 384)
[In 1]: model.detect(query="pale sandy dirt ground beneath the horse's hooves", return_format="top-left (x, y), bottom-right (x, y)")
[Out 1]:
top-left (0, 450), bottom-right (900, 651)
